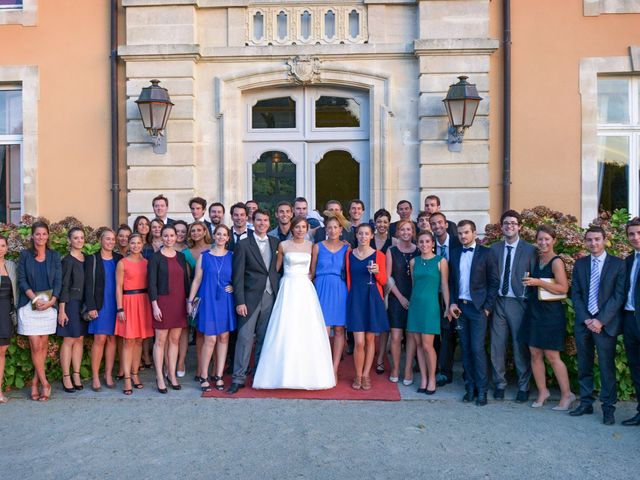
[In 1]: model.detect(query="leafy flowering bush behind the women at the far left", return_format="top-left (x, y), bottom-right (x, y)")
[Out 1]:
top-left (0, 215), bottom-right (101, 389)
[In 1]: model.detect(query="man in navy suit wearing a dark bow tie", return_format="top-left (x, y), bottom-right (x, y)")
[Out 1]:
top-left (449, 220), bottom-right (500, 406)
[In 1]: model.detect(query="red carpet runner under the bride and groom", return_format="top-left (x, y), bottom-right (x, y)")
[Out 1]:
top-left (202, 356), bottom-right (400, 402)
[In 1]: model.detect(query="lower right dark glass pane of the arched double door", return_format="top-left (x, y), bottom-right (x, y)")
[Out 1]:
top-left (316, 150), bottom-right (360, 210)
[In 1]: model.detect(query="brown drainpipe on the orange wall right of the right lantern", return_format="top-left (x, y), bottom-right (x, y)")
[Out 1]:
top-left (502, 0), bottom-right (511, 212)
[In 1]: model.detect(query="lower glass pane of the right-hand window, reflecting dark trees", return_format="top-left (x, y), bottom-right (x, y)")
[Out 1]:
top-left (598, 137), bottom-right (629, 212)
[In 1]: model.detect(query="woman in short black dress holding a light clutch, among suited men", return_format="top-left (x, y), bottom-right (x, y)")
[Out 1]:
top-left (520, 225), bottom-right (576, 411)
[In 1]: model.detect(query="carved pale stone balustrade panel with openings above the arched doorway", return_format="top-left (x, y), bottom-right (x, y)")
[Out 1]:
top-left (246, 2), bottom-right (369, 46)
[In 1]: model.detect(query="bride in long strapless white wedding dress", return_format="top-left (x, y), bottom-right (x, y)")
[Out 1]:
top-left (253, 217), bottom-right (336, 390)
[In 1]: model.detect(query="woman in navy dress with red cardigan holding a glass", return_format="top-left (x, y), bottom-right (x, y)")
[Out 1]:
top-left (345, 223), bottom-right (389, 390)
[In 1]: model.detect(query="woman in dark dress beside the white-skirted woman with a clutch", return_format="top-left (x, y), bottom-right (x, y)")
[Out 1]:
top-left (56, 227), bottom-right (87, 393)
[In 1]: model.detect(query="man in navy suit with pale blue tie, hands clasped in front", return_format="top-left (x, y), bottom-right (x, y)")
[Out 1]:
top-left (569, 226), bottom-right (626, 425)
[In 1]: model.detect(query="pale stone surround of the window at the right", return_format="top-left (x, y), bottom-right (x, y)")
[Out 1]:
top-left (580, 50), bottom-right (637, 227)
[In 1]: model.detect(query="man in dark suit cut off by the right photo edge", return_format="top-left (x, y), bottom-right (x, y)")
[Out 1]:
top-left (622, 217), bottom-right (640, 427)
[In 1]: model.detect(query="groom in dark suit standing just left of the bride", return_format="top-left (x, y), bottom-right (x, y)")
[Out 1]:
top-left (227, 209), bottom-right (280, 394)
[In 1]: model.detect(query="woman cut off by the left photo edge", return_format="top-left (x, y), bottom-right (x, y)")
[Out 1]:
top-left (0, 237), bottom-right (17, 404)
